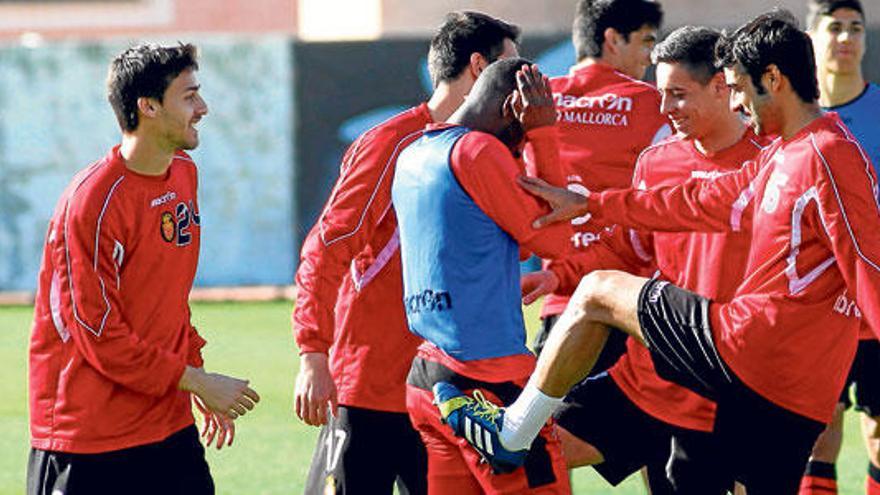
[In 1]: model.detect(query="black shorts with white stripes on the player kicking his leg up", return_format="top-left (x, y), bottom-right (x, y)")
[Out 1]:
top-left (638, 280), bottom-right (824, 495)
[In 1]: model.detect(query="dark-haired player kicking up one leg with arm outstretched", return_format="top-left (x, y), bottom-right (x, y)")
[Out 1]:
top-left (438, 11), bottom-right (880, 494)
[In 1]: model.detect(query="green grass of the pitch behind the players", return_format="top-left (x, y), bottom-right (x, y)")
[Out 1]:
top-left (0, 302), bottom-right (867, 495)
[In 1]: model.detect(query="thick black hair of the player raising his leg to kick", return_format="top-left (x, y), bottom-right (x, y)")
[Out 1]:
top-left (715, 9), bottom-right (819, 103)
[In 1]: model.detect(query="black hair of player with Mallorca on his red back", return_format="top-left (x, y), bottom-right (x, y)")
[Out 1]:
top-left (571, 0), bottom-right (663, 61)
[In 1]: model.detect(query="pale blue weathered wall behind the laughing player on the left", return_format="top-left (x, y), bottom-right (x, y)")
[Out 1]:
top-left (0, 37), bottom-right (295, 291)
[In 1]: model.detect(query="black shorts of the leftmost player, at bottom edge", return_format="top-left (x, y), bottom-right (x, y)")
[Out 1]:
top-left (27, 426), bottom-right (214, 495)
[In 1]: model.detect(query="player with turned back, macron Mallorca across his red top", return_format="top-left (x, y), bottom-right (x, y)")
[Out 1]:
top-left (525, 0), bottom-right (670, 371)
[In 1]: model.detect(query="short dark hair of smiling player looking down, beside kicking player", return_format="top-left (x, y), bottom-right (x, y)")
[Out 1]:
top-left (651, 26), bottom-right (721, 86)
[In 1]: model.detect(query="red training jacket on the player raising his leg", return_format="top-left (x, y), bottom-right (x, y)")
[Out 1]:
top-left (590, 114), bottom-right (880, 423)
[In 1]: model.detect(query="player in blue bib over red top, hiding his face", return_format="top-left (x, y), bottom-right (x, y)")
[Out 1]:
top-left (392, 59), bottom-right (571, 495)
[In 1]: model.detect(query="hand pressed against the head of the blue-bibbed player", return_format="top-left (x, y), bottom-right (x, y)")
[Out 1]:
top-left (512, 65), bottom-right (556, 132)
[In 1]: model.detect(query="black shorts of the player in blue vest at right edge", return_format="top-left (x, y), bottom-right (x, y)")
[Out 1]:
top-left (840, 339), bottom-right (880, 417)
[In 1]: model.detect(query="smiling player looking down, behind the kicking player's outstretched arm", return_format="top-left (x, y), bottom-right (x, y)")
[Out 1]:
top-left (524, 27), bottom-right (766, 495)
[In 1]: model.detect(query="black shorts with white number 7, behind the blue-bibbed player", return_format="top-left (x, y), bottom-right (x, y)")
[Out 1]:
top-left (305, 406), bottom-right (428, 495)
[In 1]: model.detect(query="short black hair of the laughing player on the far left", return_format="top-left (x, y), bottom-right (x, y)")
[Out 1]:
top-left (107, 43), bottom-right (199, 132)
